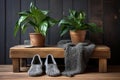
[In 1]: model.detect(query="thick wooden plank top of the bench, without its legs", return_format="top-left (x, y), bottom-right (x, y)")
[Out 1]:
top-left (10, 45), bottom-right (110, 58)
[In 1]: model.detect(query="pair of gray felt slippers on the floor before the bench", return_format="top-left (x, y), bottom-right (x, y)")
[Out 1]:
top-left (28, 54), bottom-right (60, 77)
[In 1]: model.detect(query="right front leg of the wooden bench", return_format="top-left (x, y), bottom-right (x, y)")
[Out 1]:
top-left (99, 59), bottom-right (107, 72)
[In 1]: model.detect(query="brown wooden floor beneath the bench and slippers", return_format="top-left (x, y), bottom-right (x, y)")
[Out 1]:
top-left (0, 65), bottom-right (120, 80)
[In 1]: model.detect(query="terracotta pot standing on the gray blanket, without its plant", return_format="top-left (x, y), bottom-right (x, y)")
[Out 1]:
top-left (70, 30), bottom-right (86, 44)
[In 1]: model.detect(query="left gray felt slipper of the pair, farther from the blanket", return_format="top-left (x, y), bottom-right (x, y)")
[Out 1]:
top-left (28, 54), bottom-right (43, 77)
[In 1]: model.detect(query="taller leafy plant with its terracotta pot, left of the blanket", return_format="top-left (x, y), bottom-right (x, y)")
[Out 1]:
top-left (14, 2), bottom-right (57, 46)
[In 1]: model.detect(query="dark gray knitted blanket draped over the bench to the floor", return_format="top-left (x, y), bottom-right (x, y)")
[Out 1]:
top-left (57, 40), bottom-right (95, 76)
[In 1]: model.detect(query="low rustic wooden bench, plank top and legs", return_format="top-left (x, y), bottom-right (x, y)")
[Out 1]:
top-left (9, 45), bottom-right (110, 72)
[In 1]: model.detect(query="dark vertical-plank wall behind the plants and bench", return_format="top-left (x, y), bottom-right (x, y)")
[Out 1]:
top-left (0, 0), bottom-right (120, 64)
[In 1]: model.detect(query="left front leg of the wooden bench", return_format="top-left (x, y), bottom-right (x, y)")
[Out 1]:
top-left (12, 58), bottom-right (20, 72)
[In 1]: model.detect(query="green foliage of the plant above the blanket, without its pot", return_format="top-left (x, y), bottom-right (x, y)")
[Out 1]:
top-left (58, 10), bottom-right (102, 36)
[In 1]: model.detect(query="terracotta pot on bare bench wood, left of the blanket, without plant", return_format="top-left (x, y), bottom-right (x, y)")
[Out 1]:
top-left (30, 33), bottom-right (45, 47)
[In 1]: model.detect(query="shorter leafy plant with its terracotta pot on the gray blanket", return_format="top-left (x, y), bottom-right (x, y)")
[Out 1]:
top-left (58, 10), bottom-right (102, 44)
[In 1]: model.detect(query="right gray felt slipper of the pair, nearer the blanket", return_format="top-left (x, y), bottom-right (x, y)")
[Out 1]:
top-left (45, 54), bottom-right (60, 76)
